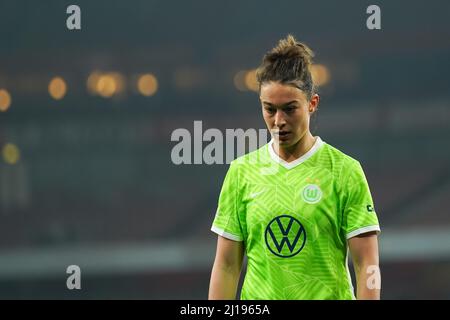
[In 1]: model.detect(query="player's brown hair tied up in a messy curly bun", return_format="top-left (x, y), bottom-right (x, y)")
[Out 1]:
top-left (256, 34), bottom-right (314, 99)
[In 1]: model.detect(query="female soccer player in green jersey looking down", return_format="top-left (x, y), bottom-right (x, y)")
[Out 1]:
top-left (209, 35), bottom-right (381, 300)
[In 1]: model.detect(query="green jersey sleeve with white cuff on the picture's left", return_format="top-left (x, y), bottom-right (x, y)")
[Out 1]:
top-left (211, 162), bottom-right (244, 241)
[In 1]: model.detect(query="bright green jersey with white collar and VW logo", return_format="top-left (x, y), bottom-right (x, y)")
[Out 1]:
top-left (211, 137), bottom-right (380, 300)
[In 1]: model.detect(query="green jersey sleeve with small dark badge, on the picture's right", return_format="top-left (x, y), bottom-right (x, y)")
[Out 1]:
top-left (342, 160), bottom-right (381, 239)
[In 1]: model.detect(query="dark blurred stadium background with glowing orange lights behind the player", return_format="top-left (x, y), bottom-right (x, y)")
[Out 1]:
top-left (0, 0), bottom-right (450, 299)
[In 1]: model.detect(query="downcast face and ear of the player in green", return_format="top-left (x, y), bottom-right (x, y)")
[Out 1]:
top-left (260, 82), bottom-right (319, 147)
